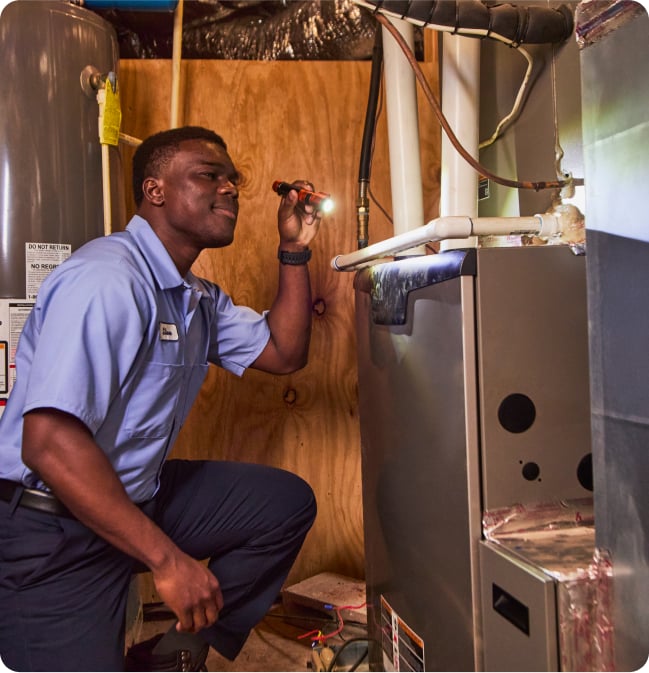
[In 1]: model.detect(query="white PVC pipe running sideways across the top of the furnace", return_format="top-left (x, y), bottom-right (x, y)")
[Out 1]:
top-left (331, 213), bottom-right (562, 271)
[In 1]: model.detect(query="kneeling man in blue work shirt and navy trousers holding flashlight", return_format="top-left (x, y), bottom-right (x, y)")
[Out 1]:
top-left (0, 127), bottom-right (319, 671)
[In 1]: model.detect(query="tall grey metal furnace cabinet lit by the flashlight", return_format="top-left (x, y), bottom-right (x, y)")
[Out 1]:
top-left (355, 246), bottom-right (592, 671)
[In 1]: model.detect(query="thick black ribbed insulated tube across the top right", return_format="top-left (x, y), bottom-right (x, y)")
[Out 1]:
top-left (355, 0), bottom-right (574, 46)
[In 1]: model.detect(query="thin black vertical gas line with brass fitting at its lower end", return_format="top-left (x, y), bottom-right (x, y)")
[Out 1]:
top-left (356, 27), bottom-right (383, 250)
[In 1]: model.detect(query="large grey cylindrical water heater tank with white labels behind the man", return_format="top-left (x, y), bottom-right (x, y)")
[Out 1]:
top-left (0, 0), bottom-right (125, 413)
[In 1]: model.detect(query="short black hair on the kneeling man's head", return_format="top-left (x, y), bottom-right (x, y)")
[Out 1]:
top-left (133, 126), bottom-right (228, 208)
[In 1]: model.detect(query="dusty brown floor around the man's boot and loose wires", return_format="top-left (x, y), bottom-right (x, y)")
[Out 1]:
top-left (137, 603), bottom-right (369, 673)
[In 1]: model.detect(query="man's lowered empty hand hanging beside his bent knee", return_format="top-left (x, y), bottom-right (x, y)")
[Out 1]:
top-left (153, 550), bottom-right (223, 633)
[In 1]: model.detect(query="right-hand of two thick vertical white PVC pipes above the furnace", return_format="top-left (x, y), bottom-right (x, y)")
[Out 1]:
top-left (439, 33), bottom-right (480, 250)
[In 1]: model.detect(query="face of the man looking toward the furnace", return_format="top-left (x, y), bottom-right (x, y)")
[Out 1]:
top-left (157, 140), bottom-right (240, 252)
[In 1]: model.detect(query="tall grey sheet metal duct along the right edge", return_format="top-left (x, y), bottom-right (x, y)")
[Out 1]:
top-left (578, 3), bottom-right (649, 671)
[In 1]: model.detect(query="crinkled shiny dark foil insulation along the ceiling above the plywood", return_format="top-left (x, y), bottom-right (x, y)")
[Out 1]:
top-left (93, 0), bottom-right (376, 61)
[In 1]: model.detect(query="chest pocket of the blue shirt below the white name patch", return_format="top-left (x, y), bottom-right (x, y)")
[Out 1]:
top-left (124, 362), bottom-right (183, 439)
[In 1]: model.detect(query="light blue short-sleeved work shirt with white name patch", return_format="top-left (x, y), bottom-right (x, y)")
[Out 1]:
top-left (0, 215), bottom-right (270, 502)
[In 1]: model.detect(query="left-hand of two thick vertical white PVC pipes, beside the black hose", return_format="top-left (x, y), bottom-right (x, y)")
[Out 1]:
top-left (382, 19), bottom-right (424, 249)
